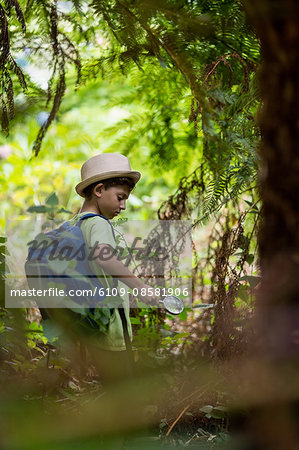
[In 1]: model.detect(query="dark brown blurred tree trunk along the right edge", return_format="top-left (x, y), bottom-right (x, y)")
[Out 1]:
top-left (244, 0), bottom-right (299, 449)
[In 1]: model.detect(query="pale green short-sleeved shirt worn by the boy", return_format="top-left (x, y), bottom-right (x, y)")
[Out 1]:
top-left (69, 212), bottom-right (132, 351)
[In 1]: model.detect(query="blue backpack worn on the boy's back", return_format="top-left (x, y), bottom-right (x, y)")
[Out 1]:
top-left (25, 213), bottom-right (115, 324)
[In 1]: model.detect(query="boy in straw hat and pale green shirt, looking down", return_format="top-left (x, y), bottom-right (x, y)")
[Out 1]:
top-left (71, 153), bottom-right (156, 381)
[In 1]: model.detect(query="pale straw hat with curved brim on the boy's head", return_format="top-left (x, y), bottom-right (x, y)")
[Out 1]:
top-left (75, 153), bottom-right (141, 197)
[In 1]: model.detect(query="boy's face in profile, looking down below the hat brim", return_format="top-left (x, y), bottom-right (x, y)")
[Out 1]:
top-left (94, 183), bottom-right (130, 219)
